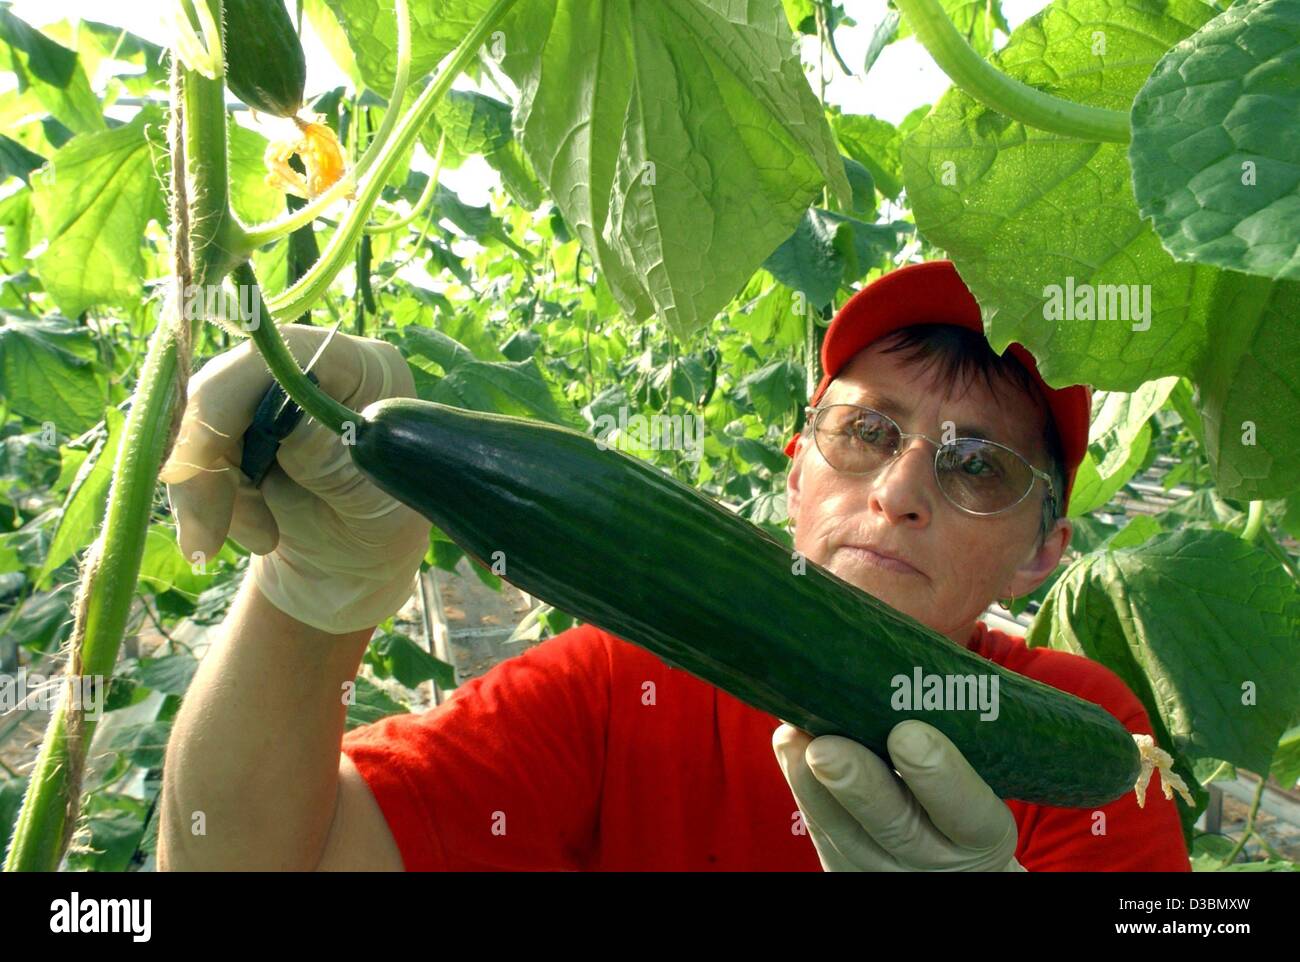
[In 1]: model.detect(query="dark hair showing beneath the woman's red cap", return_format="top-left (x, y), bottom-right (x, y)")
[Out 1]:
top-left (816, 324), bottom-right (1065, 543)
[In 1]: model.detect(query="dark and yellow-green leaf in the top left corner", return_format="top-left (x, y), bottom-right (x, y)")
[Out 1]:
top-left (0, 8), bottom-right (104, 133)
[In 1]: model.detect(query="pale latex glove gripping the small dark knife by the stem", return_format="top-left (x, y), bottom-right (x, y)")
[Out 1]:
top-left (161, 324), bottom-right (429, 634)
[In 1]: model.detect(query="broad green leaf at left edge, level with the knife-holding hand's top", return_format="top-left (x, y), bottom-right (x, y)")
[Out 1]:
top-left (0, 312), bottom-right (107, 434)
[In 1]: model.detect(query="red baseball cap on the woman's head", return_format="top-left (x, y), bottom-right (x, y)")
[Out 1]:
top-left (785, 260), bottom-right (1092, 511)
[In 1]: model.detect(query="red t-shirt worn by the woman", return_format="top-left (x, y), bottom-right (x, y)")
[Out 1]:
top-left (343, 623), bottom-right (1188, 871)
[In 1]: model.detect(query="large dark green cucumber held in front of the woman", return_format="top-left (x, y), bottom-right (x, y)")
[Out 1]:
top-left (352, 398), bottom-right (1141, 806)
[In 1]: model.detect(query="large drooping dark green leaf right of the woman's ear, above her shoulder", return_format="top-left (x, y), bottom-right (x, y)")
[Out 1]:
top-left (1028, 530), bottom-right (1300, 772)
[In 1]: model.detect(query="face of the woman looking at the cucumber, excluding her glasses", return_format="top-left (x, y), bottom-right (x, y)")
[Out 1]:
top-left (787, 342), bottom-right (1071, 645)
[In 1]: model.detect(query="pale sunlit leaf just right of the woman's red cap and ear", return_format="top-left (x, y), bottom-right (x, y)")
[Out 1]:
top-left (1069, 377), bottom-right (1178, 517)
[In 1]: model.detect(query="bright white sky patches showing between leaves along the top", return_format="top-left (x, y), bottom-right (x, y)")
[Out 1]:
top-left (10, 0), bottom-right (1047, 207)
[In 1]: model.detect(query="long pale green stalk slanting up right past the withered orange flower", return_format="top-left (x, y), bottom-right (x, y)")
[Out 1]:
top-left (267, 0), bottom-right (516, 323)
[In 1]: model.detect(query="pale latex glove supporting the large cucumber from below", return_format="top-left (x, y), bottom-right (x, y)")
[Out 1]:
top-left (772, 719), bottom-right (1024, 872)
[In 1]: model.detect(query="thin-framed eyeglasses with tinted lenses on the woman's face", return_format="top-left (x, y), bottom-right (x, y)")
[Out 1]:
top-left (807, 404), bottom-right (1056, 516)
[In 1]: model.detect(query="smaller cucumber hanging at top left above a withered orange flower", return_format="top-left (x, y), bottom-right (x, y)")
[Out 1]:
top-left (225, 0), bottom-right (307, 117)
